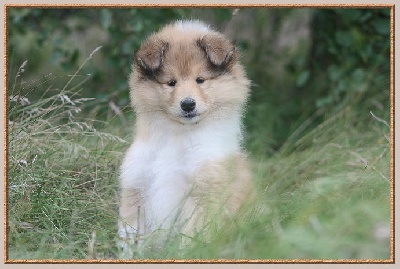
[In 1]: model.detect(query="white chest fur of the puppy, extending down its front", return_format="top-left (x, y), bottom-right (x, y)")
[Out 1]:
top-left (121, 113), bottom-right (241, 229)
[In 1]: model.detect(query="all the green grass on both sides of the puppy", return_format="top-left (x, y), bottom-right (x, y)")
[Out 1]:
top-left (7, 56), bottom-right (390, 260)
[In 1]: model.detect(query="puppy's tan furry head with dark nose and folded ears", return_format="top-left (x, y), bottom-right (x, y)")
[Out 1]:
top-left (130, 21), bottom-right (248, 124)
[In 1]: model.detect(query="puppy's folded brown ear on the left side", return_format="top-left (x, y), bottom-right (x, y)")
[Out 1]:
top-left (136, 37), bottom-right (168, 73)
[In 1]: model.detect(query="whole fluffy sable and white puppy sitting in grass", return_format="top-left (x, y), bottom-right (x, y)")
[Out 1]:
top-left (119, 21), bottom-right (252, 248)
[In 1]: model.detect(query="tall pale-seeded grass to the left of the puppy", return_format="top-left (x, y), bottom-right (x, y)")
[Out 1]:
top-left (7, 54), bottom-right (127, 259)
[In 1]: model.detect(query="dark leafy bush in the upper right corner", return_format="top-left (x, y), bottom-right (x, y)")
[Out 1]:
top-left (297, 9), bottom-right (390, 107)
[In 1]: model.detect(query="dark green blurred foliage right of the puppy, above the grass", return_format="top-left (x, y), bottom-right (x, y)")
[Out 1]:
top-left (246, 9), bottom-right (390, 155)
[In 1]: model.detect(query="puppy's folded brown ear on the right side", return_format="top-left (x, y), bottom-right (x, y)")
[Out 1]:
top-left (197, 34), bottom-right (237, 68)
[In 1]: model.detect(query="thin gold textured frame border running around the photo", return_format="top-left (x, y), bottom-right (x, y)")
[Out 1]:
top-left (3, 4), bottom-right (395, 264)
